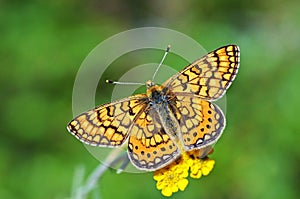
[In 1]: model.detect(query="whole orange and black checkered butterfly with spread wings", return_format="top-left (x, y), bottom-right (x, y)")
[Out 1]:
top-left (67, 45), bottom-right (240, 171)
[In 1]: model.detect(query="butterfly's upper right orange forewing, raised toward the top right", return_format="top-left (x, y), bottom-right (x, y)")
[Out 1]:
top-left (163, 45), bottom-right (240, 100)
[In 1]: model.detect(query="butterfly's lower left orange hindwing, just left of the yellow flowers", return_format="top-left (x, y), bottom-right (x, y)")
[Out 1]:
top-left (128, 109), bottom-right (180, 171)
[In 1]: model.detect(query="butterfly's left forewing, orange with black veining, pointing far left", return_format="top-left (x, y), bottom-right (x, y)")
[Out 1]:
top-left (67, 94), bottom-right (147, 147)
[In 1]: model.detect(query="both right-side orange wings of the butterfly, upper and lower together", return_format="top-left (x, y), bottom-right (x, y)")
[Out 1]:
top-left (163, 45), bottom-right (240, 150)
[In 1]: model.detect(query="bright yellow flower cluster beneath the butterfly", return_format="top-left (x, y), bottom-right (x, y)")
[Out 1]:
top-left (153, 148), bottom-right (215, 196)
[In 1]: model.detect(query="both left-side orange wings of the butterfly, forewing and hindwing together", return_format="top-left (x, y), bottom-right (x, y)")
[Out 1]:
top-left (67, 94), bottom-right (180, 171)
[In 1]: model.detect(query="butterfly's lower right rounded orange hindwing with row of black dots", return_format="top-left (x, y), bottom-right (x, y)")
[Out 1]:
top-left (176, 95), bottom-right (225, 151)
